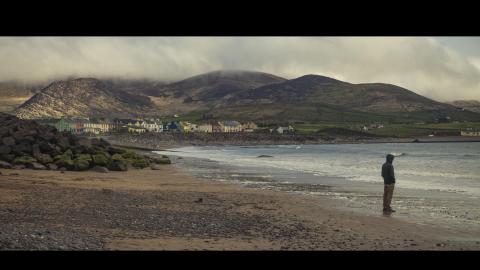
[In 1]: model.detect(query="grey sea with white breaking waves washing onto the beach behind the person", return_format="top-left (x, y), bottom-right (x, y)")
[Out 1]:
top-left (154, 142), bottom-right (480, 234)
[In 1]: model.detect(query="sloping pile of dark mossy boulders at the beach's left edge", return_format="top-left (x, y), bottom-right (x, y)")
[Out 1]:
top-left (0, 113), bottom-right (171, 172)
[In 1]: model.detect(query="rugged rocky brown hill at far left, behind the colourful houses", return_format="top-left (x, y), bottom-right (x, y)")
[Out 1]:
top-left (15, 78), bottom-right (156, 119)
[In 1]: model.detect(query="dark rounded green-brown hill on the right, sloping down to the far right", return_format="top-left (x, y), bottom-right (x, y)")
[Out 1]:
top-left (216, 75), bottom-right (480, 121)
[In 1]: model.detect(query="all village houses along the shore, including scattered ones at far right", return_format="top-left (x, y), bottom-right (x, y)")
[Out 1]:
top-left (33, 117), bottom-right (480, 137)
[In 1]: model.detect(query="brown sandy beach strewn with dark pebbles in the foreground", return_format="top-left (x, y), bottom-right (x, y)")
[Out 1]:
top-left (0, 165), bottom-right (480, 250)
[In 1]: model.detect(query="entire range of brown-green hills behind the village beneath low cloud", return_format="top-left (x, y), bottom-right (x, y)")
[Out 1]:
top-left (9, 70), bottom-right (480, 122)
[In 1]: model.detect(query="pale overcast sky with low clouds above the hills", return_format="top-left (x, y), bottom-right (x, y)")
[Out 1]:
top-left (0, 37), bottom-right (480, 101)
